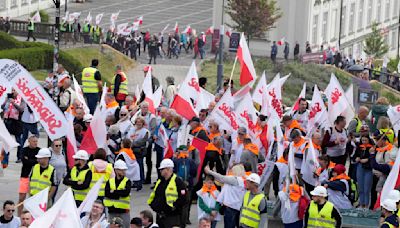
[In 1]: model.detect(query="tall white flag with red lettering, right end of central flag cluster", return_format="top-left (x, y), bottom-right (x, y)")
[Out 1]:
top-left (325, 74), bottom-right (349, 126)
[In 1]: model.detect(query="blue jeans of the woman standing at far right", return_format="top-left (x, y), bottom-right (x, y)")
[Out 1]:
top-left (357, 164), bottom-right (373, 206)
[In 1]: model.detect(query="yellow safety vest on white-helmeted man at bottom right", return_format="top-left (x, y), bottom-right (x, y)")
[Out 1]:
top-left (308, 201), bottom-right (336, 228)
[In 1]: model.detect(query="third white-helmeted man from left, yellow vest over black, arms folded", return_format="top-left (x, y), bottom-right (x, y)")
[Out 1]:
top-left (104, 160), bottom-right (132, 227)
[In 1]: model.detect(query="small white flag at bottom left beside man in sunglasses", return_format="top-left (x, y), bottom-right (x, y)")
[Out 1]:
top-left (24, 187), bottom-right (49, 219)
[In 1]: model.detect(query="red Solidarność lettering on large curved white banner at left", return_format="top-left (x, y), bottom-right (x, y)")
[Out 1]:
top-left (16, 78), bottom-right (62, 134)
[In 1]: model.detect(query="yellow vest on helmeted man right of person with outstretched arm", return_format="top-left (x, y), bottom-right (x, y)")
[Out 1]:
top-left (240, 191), bottom-right (265, 228)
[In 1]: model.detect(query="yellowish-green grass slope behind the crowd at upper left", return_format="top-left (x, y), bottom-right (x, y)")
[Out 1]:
top-left (65, 45), bottom-right (136, 84)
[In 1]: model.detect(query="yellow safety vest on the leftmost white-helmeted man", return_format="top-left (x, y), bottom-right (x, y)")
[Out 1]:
top-left (29, 164), bottom-right (54, 196)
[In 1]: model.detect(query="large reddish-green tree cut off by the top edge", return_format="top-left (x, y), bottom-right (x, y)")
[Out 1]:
top-left (225, 0), bottom-right (282, 41)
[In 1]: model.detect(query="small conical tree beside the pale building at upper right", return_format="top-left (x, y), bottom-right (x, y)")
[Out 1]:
top-left (364, 22), bottom-right (389, 58)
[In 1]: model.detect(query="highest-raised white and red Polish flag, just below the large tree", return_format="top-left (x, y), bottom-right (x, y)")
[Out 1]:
top-left (236, 33), bottom-right (257, 86)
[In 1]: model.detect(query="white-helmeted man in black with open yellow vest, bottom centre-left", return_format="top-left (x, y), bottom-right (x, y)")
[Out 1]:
top-left (147, 159), bottom-right (187, 228)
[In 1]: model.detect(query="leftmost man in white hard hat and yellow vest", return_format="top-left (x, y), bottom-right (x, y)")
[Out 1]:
top-left (29, 148), bottom-right (57, 199)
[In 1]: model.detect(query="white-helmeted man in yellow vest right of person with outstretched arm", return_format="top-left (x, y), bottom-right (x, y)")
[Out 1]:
top-left (239, 173), bottom-right (267, 228)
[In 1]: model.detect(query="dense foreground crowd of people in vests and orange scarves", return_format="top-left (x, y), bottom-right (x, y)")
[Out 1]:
top-left (0, 55), bottom-right (400, 228)
